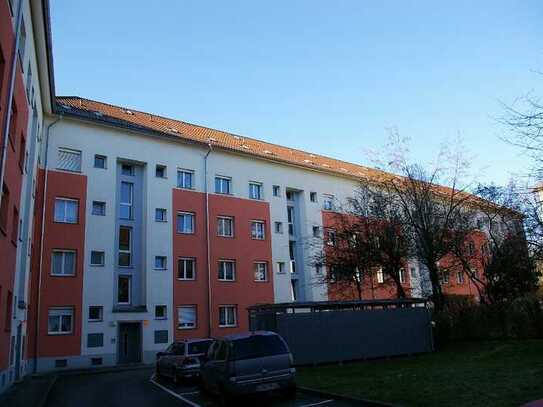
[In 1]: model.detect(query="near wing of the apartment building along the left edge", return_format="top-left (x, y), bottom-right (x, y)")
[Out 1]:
top-left (0, 0), bottom-right (52, 392)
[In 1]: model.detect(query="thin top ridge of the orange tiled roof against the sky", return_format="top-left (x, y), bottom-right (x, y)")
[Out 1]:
top-left (57, 96), bottom-right (378, 178)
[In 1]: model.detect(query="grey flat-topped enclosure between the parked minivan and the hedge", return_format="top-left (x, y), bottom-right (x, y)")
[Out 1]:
top-left (249, 299), bottom-right (433, 365)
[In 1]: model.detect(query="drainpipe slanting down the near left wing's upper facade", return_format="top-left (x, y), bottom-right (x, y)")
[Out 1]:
top-left (0, 0), bottom-right (23, 209)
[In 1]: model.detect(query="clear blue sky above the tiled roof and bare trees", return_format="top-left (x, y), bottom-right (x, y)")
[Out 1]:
top-left (51, 0), bottom-right (543, 183)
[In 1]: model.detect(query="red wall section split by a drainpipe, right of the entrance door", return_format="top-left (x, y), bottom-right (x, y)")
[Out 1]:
top-left (172, 189), bottom-right (273, 339)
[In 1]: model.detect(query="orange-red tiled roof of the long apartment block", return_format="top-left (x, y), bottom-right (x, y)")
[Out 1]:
top-left (57, 96), bottom-right (390, 180)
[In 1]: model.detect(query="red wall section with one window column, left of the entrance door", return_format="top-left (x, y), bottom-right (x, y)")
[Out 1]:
top-left (29, 171), bottom-right (87, 357)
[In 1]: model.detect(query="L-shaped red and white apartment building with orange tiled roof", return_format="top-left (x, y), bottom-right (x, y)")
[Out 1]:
top-left (0, 0), bottom-right (496, 391)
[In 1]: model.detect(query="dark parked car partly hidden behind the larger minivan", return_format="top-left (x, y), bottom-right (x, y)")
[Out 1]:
top-left (156, 339), bottom-right (213, 383)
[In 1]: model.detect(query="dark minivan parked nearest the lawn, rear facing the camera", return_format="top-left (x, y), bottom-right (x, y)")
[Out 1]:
top-left (200, 331), bottom-right (296, 404)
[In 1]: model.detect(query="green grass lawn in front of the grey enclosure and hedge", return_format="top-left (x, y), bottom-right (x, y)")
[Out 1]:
top-left (297, 340), bottom-right (543, 407)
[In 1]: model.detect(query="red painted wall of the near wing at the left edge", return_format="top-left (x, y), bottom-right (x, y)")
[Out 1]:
top-left (0, 1), bottom-right (28, 370)
